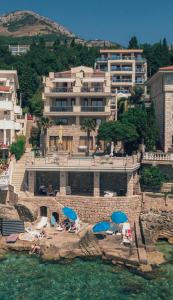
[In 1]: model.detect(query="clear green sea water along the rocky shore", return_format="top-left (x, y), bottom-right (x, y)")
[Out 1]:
top-left (0, 241), bottom-right (173, 300)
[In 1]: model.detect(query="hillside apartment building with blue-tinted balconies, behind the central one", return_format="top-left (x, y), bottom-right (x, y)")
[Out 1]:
top-left (96, 49), bottom-right (147, 98)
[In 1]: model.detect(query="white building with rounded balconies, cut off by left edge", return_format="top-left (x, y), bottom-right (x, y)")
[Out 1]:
top-left (0, 70), bottom-right (22, 148)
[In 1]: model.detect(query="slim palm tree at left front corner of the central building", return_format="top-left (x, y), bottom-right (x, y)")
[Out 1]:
top-left (38, 117), bottom-right (54, 156)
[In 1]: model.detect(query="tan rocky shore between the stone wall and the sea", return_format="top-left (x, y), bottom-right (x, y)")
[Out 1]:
top-left (0, 225), bottom-right (165, 272)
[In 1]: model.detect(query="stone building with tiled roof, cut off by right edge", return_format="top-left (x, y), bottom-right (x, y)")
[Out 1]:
top-left (147, 66), bottom-right (173, 152)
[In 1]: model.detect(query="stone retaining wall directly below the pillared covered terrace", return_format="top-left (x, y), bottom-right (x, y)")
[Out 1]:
top-left (19, 196), bottom-right (141, 223)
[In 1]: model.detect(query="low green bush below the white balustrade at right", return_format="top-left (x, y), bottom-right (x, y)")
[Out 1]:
top-left (141, 167), bottom-right (168, 188)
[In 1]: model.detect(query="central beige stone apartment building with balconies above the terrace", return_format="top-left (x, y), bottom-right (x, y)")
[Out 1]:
top-left (43, 66), bottom-right (115, 153)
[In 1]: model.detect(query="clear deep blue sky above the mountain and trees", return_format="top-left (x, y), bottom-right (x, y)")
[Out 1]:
top-left (0, 0), bottom-right (173, 46)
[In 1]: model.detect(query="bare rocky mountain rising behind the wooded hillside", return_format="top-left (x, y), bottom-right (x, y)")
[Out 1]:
top-left (0, 11), bottom-right (119, 47)
